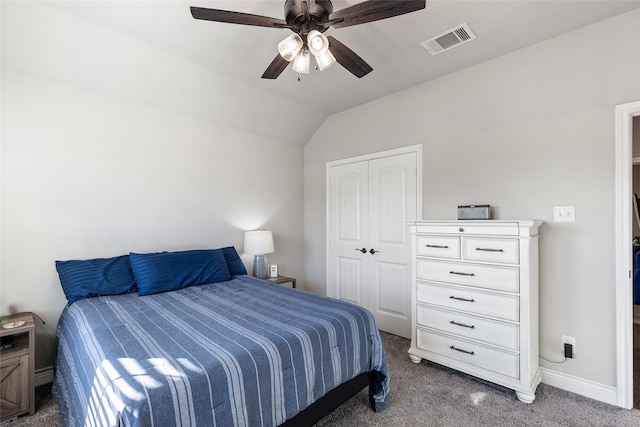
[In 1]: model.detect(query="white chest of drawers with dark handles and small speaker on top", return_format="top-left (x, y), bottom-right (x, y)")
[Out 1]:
top-left (409, 220), bottom-right (542, 403)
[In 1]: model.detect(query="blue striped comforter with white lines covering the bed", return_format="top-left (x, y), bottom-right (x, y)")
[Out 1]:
top-left (54, 276), bottom-right (389, 427)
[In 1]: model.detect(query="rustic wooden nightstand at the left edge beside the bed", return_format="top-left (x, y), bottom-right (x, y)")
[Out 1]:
top-left (0, 313), bottom-right (36, 421)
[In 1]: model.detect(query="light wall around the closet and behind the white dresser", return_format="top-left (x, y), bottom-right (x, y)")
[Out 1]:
top-left (304, 10), bottom-right (640, 396)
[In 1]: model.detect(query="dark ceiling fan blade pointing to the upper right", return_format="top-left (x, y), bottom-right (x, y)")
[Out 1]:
top-left (329, 0), bottom-right (426, 28)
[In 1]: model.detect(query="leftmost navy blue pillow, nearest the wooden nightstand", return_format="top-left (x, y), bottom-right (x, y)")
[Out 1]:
top-left (56, 255), bottom-right (138, 305)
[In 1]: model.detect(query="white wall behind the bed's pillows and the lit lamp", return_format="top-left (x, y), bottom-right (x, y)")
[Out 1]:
top-left (0, 2), bottom-right (304, 369)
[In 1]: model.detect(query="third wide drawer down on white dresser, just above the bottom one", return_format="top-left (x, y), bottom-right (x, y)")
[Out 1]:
top-left (417, 305), bottom-right (520, 351)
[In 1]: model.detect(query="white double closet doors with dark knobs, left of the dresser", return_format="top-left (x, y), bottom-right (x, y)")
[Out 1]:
top-left (327, 152), bottom-right (418, 338)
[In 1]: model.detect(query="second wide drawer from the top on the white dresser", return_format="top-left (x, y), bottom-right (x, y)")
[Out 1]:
top-left (416, 282), bottom-right (520, 322)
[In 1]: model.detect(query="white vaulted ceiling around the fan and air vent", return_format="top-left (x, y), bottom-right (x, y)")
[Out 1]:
top-left (46, 0), bottom-right (640, 144)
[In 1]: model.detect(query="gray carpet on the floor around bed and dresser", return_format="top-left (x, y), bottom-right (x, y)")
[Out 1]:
top-left (2, 333), bottom-right (640, 427)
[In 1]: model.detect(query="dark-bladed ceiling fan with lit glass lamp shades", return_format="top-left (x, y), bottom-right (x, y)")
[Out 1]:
top-left (191, 0), bottom-right (425, 79)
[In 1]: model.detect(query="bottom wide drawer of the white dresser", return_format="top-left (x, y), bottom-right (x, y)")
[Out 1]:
top-left (416, 328), bottom-right (520, 379)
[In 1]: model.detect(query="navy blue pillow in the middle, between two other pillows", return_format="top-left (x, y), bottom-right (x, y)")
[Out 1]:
top-left (129, 249), bottom-right (231, 295)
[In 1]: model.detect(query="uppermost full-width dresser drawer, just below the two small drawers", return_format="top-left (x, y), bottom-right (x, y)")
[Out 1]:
top-left (416, 259), bottom-right (520, 292)
